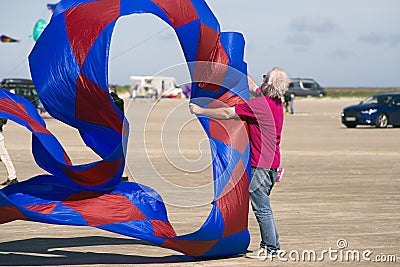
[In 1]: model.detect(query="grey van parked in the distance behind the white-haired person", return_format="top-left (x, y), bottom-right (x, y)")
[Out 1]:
top-left (286, 78), bottom-right (326, 97)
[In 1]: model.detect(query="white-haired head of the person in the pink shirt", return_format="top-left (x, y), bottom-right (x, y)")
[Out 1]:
top-left (261, 67), bottom-right (290, 98)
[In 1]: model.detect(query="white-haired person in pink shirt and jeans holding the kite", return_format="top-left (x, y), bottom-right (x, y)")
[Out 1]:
top-left (189, 68), bottom-right (290, 259)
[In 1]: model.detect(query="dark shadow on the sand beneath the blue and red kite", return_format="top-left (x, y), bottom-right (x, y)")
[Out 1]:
top-left (0, 236), bottom-right (195, 266)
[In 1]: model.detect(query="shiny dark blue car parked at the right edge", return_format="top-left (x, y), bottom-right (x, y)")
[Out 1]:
top-left (342, 92), bottom-right (400, 128)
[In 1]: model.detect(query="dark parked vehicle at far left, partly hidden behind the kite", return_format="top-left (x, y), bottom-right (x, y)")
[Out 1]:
top-left (0, 78), bottom-right (40, 108)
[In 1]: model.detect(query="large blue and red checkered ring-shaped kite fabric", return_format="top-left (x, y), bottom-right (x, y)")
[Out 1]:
top-left (0, 0), bottom-right (251, 258)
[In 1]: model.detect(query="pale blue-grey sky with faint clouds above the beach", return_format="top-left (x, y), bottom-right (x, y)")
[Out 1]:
top-left (0, 0), bottom-right (400, 87)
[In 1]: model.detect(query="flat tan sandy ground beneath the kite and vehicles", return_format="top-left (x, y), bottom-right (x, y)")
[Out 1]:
top-left (0, 98), bottom-right (400, 266)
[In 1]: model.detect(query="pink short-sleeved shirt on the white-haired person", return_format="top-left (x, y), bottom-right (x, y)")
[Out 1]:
top-left (235, 96), bottom-right (284, 168)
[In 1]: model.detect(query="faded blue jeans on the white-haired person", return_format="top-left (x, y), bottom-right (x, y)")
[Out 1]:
top-left (250, 167), bottom-right (280, 254)
